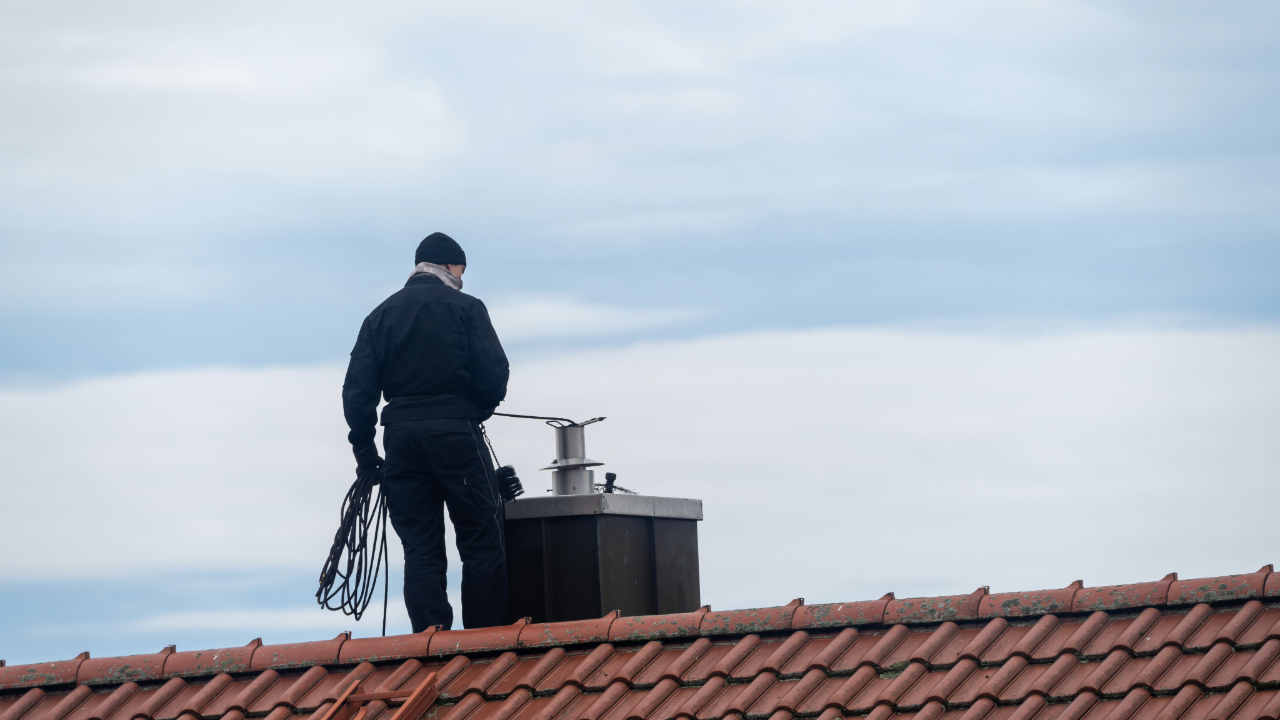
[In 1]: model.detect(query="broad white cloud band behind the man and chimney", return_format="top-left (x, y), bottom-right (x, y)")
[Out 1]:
top-left (0, 328), bottom-right (1280, 609)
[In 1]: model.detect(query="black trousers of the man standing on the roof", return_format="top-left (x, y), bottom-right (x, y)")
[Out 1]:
top-left (383, 419), bottom-right (507, 633)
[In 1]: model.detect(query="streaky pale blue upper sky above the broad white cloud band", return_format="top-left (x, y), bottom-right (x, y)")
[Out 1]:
top-left (0, 3), bottom-right (1280, 380)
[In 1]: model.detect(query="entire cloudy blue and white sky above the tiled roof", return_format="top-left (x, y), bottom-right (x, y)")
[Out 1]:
top-left (0, 1), bottom-right (1280, 664)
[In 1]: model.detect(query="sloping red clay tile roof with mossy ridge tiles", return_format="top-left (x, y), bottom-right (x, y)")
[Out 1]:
top-left (0, 566), bottom-right (1280, 720)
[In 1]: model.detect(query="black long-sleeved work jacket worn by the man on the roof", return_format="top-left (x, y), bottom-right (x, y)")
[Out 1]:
top-left (342, 275), bottom-right (511, 450)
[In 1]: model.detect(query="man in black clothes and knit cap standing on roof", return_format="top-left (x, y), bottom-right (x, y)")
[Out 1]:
top-left (342, 232), bottom-right (509, 633)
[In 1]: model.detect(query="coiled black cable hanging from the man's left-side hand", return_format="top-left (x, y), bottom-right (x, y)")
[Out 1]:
top-left (316, 458), bottom-right (390, 637)
